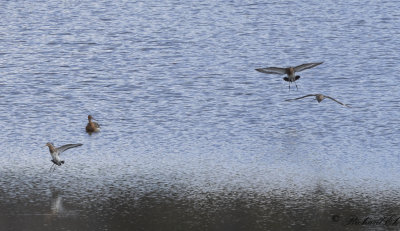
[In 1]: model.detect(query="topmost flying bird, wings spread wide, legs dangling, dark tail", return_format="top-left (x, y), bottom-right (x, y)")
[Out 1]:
top-left (256, 62), bottom-right (323, 91)
